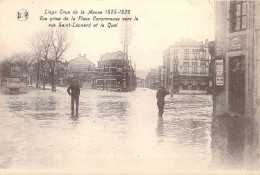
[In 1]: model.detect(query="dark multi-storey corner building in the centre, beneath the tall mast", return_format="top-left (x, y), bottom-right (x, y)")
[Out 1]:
top-left (92, 51), bottom-right (136, 91)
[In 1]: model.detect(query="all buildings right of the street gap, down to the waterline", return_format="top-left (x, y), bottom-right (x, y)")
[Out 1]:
top-left (145, 0), bottom-right (260, 121)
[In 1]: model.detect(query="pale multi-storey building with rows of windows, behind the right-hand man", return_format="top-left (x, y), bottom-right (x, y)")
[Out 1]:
top-left (163, 38), bottom-right (210, 93)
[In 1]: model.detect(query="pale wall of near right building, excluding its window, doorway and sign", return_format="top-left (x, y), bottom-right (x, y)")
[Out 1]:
top-left (214, 1), bottom-right (260, 120)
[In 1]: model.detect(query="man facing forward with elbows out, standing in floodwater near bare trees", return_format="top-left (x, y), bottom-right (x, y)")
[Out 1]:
top-left (67, 80), bottom-right (80, 116)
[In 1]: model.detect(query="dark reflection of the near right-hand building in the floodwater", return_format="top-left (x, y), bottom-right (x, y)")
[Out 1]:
top-left (211, 115), bottom-right (259, 169)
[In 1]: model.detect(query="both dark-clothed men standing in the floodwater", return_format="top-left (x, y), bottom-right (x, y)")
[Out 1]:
top-left (67, 80), bottom-right (169, 117)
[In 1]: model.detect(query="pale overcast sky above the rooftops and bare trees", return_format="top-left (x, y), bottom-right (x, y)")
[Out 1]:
top-left (0, 0), bottom-right (215, 69)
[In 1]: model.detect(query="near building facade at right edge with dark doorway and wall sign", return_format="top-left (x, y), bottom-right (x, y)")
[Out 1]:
top-left (214, 1), bottom-right (260, 118)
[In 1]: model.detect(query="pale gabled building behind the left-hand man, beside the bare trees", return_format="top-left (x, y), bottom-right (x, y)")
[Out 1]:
top-left (68, 54), bottom-right (95, 88)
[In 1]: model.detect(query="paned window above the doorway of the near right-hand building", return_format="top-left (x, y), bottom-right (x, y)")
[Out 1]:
top-left (230, 0), bottom-right (247, 32)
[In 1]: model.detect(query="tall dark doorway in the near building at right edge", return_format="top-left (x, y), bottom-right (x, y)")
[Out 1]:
top-left (229, 56), bottom-right (245, 115)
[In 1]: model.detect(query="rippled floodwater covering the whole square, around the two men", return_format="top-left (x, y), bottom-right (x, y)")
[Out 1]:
top-left (0, 88), bottom-right (258, 173)
